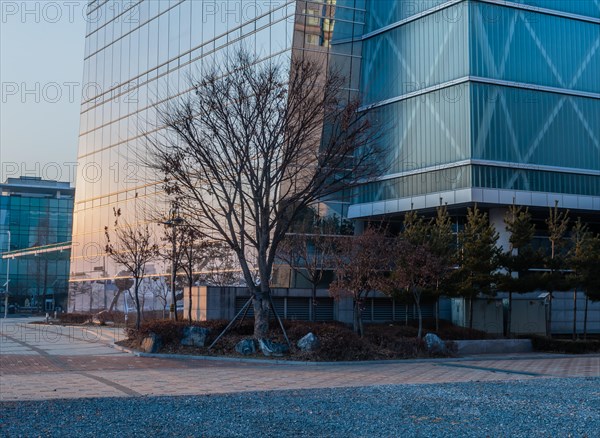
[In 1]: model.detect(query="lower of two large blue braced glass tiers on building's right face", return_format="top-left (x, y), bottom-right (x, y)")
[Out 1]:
top-left (471, 84), bottom-right (600, 170)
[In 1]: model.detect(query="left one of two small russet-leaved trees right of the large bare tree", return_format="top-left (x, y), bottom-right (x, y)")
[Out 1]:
top-left (329, 227), bottom-right (390, 336)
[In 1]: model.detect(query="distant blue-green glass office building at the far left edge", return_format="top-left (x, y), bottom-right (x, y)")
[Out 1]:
top-left (0, 177), bottom-right (74, 313)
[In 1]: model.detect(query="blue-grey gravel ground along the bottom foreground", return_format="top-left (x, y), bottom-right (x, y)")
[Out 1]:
top-left (0, 378), bottom-right (600, 438)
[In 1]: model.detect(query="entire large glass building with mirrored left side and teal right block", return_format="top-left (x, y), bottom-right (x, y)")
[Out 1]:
top-left (71, 0), bottom-right (600, 310)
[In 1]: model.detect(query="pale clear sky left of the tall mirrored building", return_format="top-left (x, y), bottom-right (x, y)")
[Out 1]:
top-left (0, 0), bottom-right (87, 183)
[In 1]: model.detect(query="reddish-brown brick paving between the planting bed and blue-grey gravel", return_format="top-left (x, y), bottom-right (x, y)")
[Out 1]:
top-left (0, 320), bottom-right (600, 401)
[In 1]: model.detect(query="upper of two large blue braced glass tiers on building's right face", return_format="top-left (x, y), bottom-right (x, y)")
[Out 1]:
top-left (469, 1), bottom-right (600, 93)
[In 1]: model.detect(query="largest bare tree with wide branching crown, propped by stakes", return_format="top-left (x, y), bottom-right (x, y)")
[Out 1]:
top-left (148, 50), bottom-right (382, 339)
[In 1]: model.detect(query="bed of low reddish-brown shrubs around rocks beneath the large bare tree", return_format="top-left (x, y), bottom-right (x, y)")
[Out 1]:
top-left (119, 320), bottom-right (485, 362)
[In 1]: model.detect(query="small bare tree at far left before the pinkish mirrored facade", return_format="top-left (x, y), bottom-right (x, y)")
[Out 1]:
top-left (104, 209), bottom-right (158, 329)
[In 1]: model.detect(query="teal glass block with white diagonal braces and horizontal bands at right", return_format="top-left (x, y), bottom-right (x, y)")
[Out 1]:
top-left (350, 0), bottom-right (600, 212)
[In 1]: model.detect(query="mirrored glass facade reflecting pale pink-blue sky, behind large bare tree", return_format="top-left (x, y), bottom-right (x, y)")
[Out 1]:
top-left (70, 0), bottom-right (365, 310)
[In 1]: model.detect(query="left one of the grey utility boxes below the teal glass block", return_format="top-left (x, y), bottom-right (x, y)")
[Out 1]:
top-left (452, 298), bottom-right (504, 336)
